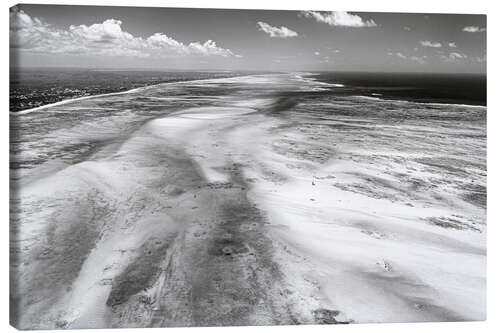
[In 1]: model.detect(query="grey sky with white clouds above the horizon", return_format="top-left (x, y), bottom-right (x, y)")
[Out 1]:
top-left (10, 5), bottom-right (487, 73)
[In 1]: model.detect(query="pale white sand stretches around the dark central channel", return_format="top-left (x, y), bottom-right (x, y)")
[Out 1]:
top-left (11, 74), bottom-right (486, 328)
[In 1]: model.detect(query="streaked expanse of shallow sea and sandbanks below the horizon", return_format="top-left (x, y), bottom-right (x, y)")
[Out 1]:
top-left (10, 72), bottom-right (487, 329)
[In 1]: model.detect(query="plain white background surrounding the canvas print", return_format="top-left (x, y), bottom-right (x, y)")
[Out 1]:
top-left (0, 0), bottom-right (500, 333)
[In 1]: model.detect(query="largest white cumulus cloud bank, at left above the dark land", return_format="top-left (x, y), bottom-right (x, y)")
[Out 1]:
top-left (10, 9), bottom-right (239, 57)
